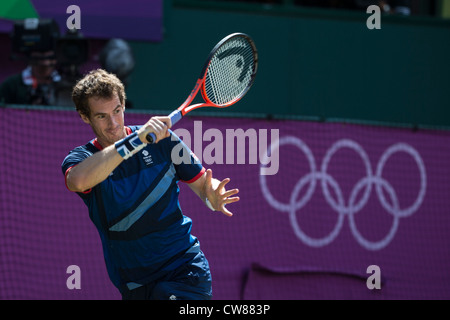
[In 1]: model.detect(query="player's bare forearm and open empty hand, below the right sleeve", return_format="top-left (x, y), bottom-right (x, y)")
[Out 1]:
top-left (189, 169), bottom-right (239, 217)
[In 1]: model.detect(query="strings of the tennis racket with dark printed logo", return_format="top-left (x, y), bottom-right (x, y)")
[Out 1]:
top-left (205, 37), bottom-right (255, 105)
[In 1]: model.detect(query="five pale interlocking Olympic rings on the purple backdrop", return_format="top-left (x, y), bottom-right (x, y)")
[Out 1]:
top-left (260, 136), bottom-right (427, 250)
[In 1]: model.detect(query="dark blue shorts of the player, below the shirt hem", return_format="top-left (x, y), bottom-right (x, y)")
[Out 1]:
top-left (122, 251), bottom-right (212, 300)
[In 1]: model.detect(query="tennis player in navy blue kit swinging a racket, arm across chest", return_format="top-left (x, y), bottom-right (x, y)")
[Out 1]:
top-left (61, 69), bottom-right (243, 300)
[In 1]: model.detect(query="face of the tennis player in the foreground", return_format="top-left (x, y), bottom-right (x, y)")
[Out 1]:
top-left (81, 94), bottom-right (126, 148)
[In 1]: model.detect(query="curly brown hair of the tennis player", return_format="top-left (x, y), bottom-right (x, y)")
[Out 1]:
top-left (72, 69), bottom-right (126, 118)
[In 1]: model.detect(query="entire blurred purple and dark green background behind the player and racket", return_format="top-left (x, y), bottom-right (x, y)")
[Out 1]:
top-left (0, 0), bottom-right (450, 299)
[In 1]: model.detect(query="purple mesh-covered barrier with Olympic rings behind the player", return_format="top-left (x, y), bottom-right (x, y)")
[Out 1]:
top-left (0, 108), bottom-right (450, 299)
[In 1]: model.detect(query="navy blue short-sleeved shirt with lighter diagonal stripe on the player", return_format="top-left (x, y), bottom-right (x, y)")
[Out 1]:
top-left (61, 126), bottom-right (205, 291)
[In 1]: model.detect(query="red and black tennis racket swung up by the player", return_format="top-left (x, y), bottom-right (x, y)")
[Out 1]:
top-left (146, 33), bottom-right (258, 143)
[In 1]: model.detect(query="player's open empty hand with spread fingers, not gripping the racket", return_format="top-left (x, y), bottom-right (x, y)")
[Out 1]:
top-left (205, 169), bottom-right (239, 217)
